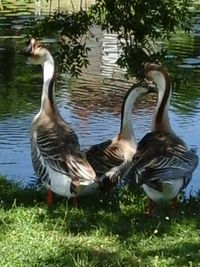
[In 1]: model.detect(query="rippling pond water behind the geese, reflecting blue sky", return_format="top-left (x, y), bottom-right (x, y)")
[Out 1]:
top-left (0, 5), bottom-right (200, 196)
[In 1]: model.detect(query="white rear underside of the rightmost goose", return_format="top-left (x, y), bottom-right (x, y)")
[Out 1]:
top-left (142, 178), bottom-right (183, 202)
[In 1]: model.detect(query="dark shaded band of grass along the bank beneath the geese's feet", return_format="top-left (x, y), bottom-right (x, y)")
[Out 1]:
top-left (0, 177), bottom-right (200, 241)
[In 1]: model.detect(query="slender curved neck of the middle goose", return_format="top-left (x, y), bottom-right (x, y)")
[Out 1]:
top-left (119, 88), bottom-right (140, 144)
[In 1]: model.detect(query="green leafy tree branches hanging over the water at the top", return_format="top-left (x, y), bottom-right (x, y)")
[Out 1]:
top-left (28, 0), bottom-right (193, 76)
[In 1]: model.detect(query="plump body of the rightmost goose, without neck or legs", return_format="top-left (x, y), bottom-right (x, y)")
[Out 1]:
top-left (134, 131), bottom-right (198, 202)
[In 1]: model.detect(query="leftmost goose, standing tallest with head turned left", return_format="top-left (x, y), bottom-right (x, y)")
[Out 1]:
top-left (21, 38), bottom-right (99, 207)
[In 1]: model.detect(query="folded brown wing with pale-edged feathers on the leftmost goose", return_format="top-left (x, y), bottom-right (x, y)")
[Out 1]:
top-left (33, 125), bottom-right (96, 185)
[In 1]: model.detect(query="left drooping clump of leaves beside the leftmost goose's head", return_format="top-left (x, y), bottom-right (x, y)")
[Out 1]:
top-left (29, 10), bottom-right (93, 76)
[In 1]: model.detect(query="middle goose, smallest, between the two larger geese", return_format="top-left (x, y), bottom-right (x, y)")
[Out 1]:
top-left (86, 81), bottom-right (154, 192)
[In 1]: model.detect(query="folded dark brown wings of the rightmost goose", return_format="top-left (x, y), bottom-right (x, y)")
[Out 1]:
top-left (132, 132), bottom-right (198, 184)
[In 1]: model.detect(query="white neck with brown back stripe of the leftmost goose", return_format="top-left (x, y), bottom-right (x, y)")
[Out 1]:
top-left (41, 53), bottom-right (58, 114)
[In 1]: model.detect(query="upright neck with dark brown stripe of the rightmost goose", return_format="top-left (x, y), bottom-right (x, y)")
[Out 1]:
top-left (152, 72), bottom-right (173, 133)
